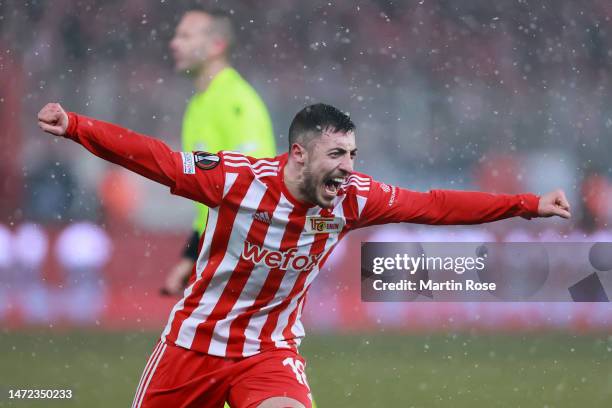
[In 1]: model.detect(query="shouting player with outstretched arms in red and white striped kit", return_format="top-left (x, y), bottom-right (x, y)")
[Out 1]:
top-left (38, 103), bottom-right (570, 408)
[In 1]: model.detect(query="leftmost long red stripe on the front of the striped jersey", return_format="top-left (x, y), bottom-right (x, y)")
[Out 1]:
top-left (166, 174), bottom-right (253, 343)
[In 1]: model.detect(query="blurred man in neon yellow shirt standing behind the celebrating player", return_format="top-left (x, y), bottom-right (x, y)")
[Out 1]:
top-left (163, 9), bottom-right (276, 295)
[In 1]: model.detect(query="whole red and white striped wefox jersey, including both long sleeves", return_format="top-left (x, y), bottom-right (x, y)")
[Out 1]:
top-left (67, 113), bottom-right (538, 357)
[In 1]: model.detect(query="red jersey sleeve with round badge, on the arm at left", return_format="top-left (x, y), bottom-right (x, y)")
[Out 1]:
top-left (66, 112), bottom-right (224, 207)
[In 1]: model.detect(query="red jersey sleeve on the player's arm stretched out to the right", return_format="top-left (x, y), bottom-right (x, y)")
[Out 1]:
top-left (358, 180), bottom-right (539, 227)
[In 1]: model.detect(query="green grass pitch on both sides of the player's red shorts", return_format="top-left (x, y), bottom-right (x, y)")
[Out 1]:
top-left (0, 330), bottom-right (612, 408)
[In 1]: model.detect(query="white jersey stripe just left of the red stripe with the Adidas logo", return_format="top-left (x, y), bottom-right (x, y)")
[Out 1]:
top-left (176, 180), bottom-right (266, 355)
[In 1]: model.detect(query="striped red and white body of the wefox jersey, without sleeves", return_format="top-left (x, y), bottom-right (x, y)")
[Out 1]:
top-left (162, 152), bottom-right (371, 357)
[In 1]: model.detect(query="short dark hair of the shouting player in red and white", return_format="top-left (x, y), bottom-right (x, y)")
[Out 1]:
top-left (289, 103), bottom-right (355, 149)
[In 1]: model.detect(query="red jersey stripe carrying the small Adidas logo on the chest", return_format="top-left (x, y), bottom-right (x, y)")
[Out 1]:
top-left (193, 189), bottom-right (280, 357)
